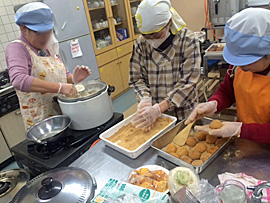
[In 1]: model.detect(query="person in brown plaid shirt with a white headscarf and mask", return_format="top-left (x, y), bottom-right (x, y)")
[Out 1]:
top-left (130, 0), bottom-right (201, 128)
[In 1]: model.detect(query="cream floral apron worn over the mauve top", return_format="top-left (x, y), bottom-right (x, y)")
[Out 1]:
top-left (14, 40), bottom-right (67, 129)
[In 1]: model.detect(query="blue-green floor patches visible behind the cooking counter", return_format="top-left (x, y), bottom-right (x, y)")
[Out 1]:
top-left (0, 89), bottom-right (137, 171)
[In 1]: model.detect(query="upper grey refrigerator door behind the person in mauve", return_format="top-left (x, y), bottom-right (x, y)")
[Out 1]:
top-left (43, 0), bottom-right (90, 42)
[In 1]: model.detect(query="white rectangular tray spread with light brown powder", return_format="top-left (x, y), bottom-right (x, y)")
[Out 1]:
top-left (100, 114), bottom-right (177, 159)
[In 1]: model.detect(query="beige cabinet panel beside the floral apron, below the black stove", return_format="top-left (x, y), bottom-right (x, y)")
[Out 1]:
top-left (0, 109), bottom-right (26, 148)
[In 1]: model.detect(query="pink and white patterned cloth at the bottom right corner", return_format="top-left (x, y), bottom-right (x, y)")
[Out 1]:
top-left (218, 172), bottom-right (270, 203)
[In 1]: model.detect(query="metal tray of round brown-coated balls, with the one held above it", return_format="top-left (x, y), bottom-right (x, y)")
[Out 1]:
top-left (151, 118), bottom-right (233, 174)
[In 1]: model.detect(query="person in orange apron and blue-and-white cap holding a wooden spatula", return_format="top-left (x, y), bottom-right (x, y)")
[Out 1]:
top-left (185, 8), bottom-right (270, 143)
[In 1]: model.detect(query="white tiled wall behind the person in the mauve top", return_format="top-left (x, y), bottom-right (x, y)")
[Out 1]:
top-left (0, 0), bottom-right (34, 72)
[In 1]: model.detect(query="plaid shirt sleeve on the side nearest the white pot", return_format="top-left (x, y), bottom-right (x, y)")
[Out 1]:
top-left (129, 43), bottom-right (151, 101)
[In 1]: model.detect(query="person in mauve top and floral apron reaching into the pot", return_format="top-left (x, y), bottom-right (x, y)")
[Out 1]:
top-left (6, 2), bottom-right (91, 129)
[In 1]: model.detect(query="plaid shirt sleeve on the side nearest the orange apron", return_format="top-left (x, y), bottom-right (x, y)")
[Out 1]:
top-left (165, 34), bottom-right (201, 108)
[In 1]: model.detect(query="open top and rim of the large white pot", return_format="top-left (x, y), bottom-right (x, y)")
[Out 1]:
top-left (58, 80), bottom-right (107, 102)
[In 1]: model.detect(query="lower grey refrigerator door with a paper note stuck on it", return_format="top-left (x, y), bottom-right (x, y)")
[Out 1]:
top-left (59, 34), bottom-right (100, 80)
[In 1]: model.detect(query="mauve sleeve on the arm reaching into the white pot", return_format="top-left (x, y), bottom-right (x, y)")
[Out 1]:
top-left (6, 43), bottom-right (34, 92)
